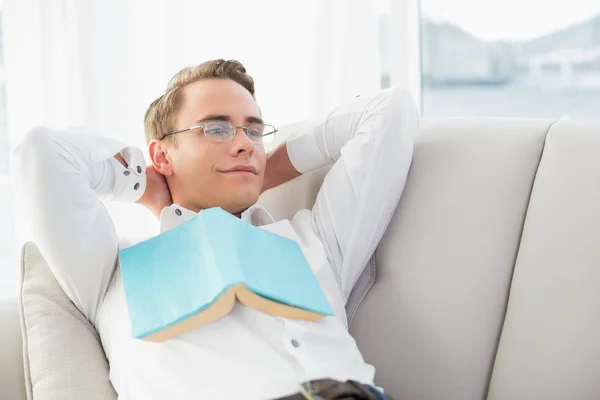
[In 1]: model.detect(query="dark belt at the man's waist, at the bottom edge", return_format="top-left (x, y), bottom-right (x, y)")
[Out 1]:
top-left (275, 379), bottom-right (393, 400)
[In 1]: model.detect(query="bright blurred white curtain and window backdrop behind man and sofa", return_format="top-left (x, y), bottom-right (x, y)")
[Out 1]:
top-left (0, 0), bottom-right (600, 294)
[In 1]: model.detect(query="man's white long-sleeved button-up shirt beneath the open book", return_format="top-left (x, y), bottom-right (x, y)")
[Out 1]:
top-left (12, 89), bottom-right (418, 400)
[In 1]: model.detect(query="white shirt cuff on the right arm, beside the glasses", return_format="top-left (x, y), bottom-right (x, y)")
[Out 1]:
top-left (286, 121), bottom-right (331, 174)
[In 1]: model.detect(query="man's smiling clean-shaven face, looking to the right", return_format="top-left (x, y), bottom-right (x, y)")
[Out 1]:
top-left (159, 79), bottom-right (266, 214)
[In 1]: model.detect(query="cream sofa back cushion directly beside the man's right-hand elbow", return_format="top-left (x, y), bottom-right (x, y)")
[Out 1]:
top-left (350, 119), bottom-right (551, 400)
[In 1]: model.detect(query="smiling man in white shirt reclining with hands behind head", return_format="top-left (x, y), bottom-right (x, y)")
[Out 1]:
top-left (13, 60), bottom-right (418, 400)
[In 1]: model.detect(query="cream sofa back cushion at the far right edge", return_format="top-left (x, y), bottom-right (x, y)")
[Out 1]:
top-left (488, 121), bottom-right (600, 400)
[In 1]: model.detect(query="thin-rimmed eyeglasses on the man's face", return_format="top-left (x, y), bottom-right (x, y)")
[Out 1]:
top-left (160, 120), bottom-right (277, 144)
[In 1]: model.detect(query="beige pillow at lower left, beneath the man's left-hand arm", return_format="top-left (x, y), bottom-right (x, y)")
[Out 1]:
top-left (20, 243), bottom-right (117, 400)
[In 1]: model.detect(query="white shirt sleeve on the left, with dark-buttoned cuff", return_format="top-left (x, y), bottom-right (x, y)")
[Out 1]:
top-left (11, 128), bottom-right (146, 324)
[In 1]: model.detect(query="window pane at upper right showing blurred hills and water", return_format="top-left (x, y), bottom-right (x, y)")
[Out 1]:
top-left (420, 0), bottom-right (600, 119)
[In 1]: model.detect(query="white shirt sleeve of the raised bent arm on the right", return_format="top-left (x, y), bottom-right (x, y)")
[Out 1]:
top-left (287, 88), bottom-right (419, 300)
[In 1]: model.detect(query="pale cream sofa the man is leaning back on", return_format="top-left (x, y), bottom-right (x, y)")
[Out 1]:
top-left (0, 119), bottom-right (600, 400)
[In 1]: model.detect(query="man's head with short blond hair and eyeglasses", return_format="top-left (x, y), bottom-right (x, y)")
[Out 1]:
top-left (144, 60), bottom-right (266, 214)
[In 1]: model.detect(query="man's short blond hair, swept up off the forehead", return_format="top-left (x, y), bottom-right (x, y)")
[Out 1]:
top-left (144, 59), bottom-right (254, 143)
